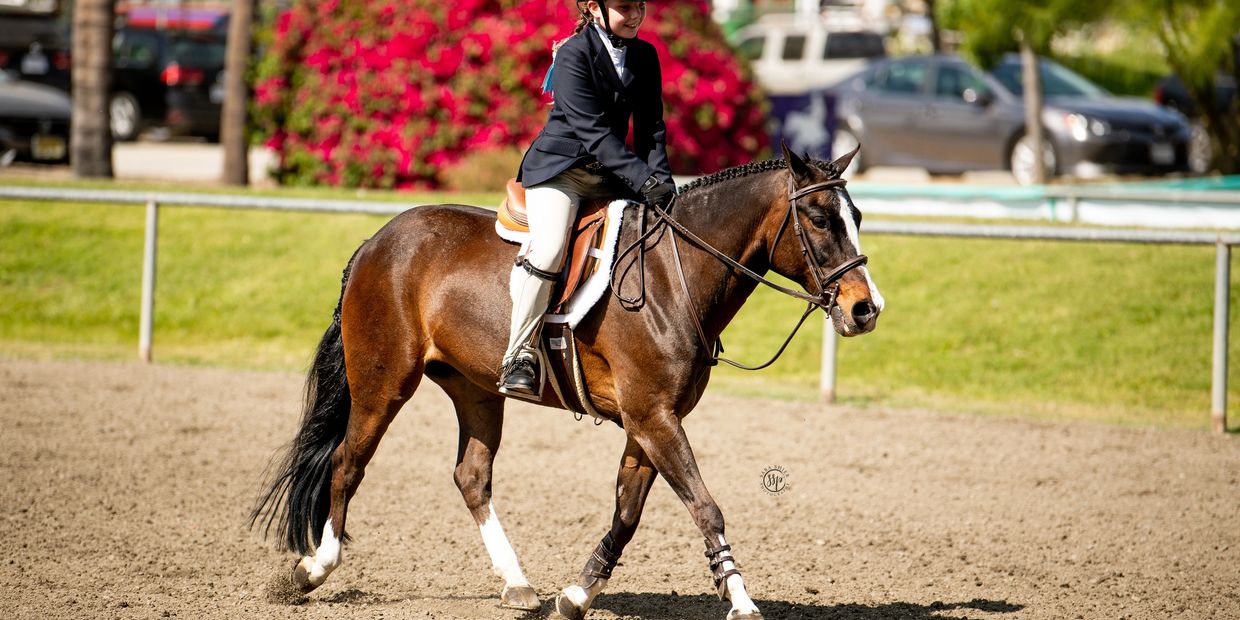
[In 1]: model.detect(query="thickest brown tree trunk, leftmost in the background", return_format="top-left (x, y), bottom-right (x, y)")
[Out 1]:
top-left (69, 0), bottom-right (115, 179)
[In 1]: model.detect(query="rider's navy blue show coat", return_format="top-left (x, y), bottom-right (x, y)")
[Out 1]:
top-left (517, 26), bottom-right (672, 192)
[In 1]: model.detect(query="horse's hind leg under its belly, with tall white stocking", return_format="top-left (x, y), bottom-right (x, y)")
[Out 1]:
top-left (432, 371), bottom-right (541, 611)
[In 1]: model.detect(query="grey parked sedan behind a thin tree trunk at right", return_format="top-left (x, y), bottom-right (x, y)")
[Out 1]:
top-left (830, 55), bottom-right (1190, 184)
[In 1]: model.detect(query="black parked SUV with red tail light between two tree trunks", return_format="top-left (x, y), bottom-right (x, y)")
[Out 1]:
top-left (110, 7), bottom-right (228, 140)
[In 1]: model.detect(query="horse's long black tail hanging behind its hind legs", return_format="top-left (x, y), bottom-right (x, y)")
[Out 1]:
top-left (249, 253), bottom-right (357, 556)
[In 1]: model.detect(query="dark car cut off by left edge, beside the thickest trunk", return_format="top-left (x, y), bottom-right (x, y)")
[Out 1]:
top-left (0, 71), bottom-right (73, 166)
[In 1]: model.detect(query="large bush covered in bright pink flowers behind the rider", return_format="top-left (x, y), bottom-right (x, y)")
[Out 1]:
top-left (254, 0), bottom-right (766, 188)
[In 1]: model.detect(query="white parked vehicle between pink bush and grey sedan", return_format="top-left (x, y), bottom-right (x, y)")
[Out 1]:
top-left (733, 20), bottom-right (887, 95)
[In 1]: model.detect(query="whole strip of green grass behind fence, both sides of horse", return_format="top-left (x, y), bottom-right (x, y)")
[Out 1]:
top-left (0, 184), bottom-right (1240, 428)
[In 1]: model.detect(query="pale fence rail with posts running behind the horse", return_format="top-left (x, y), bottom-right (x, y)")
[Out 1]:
top-left (0, 186), bottom-right (1240, 433)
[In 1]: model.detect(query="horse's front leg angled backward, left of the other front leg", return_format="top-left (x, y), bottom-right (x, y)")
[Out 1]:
top-left (556, 436), bottom-right (658, 620)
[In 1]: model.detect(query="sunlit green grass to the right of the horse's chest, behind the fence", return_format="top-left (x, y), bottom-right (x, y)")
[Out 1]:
top-left (719, 236), bottom-right (1240, 428)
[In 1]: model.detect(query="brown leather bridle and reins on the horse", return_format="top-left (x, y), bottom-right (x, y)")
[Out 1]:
top-left (611, 172), bottom-right (869, 371)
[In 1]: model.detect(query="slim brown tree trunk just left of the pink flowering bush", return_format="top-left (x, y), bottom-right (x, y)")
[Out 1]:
top-left (219, 0), bottom-right (254, 185)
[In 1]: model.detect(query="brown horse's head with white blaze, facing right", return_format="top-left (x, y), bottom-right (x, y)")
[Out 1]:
top-left (769, 145), bottom-right (883, 336)
